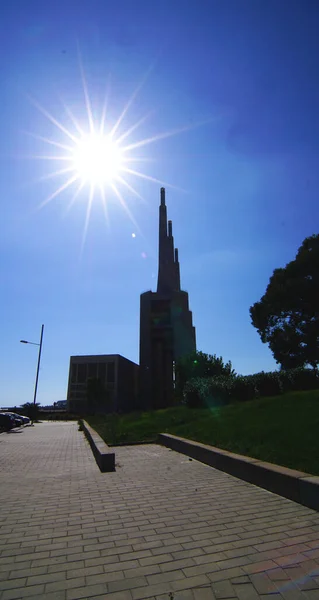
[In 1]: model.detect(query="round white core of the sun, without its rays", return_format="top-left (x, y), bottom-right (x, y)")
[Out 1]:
top-left (72, 133), bottom-right (124, 186)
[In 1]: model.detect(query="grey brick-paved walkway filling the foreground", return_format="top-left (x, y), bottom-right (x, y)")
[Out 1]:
top-left (0, 423), bottom-right (319, 600)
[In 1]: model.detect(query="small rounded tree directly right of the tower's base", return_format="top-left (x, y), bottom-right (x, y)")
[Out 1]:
top-left (175, 352), bottom-right (236, 399)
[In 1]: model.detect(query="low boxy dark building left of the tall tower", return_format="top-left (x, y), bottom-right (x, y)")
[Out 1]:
top-left (67, 354), bottom-right (139, 414)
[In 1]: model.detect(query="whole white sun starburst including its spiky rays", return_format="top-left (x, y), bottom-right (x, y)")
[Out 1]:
top-left (25, 54), bottom-right (211, 247)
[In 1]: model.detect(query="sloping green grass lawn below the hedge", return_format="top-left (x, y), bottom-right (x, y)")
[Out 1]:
top-left (87, 390), bottom-right (319, 475)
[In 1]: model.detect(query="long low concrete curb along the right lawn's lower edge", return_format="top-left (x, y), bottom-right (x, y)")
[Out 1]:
top-left (158, 433), bottom-right (319, 510)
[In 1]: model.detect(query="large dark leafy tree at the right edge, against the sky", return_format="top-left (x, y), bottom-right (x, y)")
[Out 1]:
top-left (250, 234), bottom-right (319, 370)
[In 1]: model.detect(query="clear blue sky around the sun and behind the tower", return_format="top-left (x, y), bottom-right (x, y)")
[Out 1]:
top-left (0, 0), bottom-right (319, 406)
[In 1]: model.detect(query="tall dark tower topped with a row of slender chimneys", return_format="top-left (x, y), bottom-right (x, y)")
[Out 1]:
top-left (140, 188), bottom-right (196, 409)
